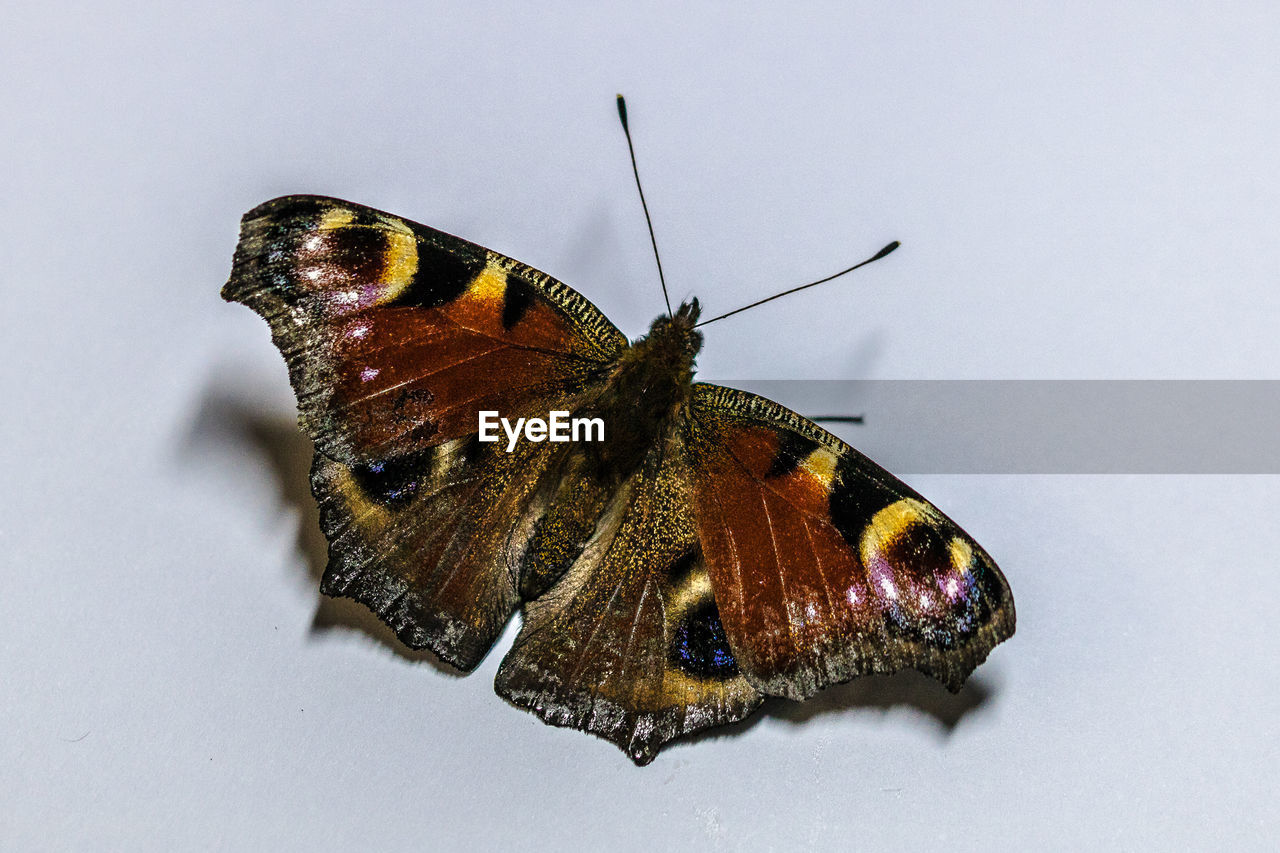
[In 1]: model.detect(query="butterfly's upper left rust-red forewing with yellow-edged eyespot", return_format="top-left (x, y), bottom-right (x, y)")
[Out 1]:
top-left (223, 196), bottom-right (626, 462)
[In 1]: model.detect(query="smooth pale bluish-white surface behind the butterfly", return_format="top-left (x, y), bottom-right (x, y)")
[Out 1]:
top-left (0, 3), bottom-right (1280, 849)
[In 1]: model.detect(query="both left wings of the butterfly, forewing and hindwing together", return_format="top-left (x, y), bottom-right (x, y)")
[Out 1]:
top-left (223, 196), bottom-right (626, 670)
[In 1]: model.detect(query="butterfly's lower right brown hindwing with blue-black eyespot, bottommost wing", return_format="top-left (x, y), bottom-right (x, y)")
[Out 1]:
top-left (495, 443), bottom-right (763, 765)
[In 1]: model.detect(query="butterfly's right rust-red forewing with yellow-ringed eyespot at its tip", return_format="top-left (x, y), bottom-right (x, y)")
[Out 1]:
top-left (687, 383), bottom-right (1015, 699)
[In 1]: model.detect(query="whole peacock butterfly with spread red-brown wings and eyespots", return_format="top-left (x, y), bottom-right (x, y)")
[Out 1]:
top-left (223, 96), bottom-right (1014, 765)
